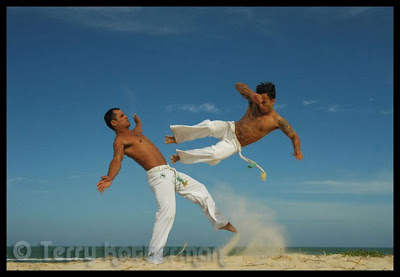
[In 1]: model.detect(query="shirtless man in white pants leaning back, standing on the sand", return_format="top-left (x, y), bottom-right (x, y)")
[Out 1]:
top-left (97, 108), bottom-right (237, 264)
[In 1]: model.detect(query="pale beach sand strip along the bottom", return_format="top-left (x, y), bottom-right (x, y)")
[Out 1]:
top-left (7, 253), bottom-right (394, 270)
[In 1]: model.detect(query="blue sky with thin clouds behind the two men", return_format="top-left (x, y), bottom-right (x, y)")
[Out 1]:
top-left (7, 7), bottom-right (393, 247)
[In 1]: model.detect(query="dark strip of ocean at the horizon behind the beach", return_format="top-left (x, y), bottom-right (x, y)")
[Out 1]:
top-left (7, 245), bottom-right (393, 263)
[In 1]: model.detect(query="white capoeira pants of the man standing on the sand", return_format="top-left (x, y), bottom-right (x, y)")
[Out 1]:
top-left (147, 165), bottom-right (228, 264)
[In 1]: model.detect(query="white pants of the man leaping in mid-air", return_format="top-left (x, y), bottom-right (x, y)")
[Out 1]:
top-left (170, 119), bottom-right (241, 165)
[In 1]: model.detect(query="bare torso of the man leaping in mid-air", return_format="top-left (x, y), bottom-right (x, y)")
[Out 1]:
top-left (235, 105), bottom-right (279, 147)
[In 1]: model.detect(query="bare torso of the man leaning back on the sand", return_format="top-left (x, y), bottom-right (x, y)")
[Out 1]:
top-left (115, 130), bottom-right (167, 171)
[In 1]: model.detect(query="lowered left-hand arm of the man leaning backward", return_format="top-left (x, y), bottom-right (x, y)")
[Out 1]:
top-left (97, 137), bottom-right (124, 193)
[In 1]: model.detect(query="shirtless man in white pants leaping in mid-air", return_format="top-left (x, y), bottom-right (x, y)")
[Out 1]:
top-left (165, 82), bottom-right (303, 168)
